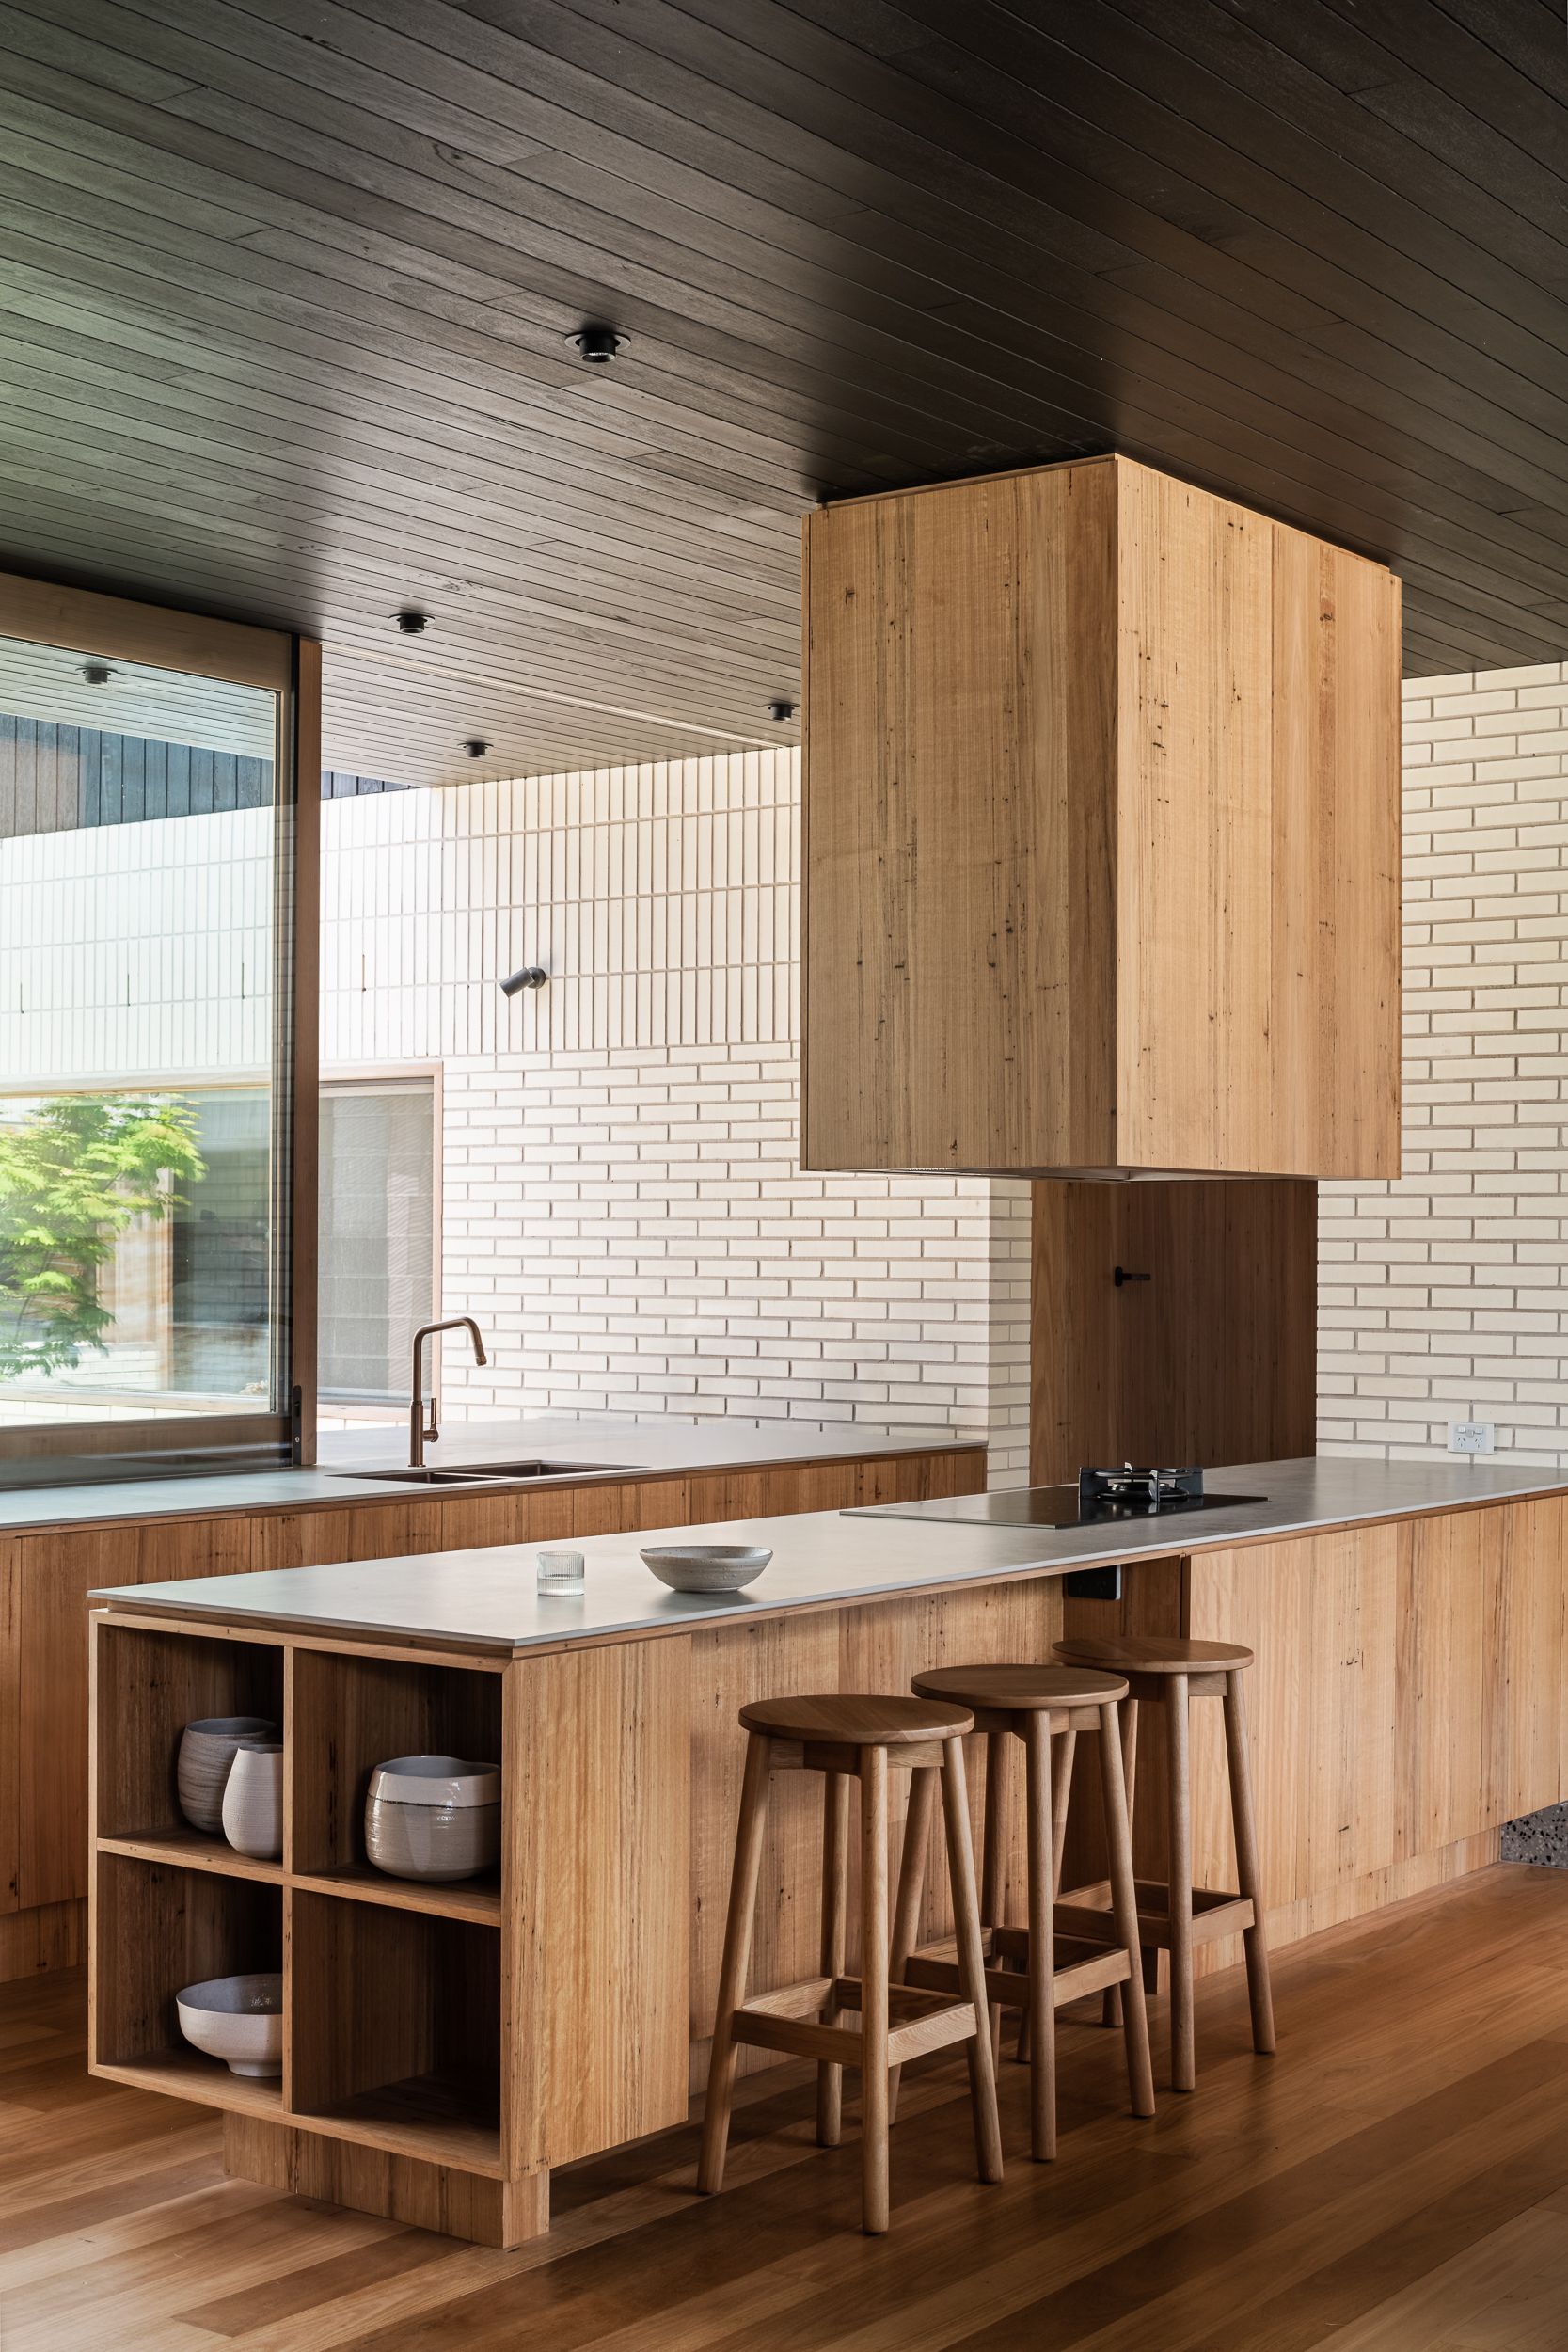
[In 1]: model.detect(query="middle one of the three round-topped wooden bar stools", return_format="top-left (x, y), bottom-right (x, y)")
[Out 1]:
top-left (894, 1665), bottom-right (1154, 2164)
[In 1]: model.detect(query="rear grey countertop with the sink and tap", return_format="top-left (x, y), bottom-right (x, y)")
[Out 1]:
top-left (0, 1414), bottom-right (983, 1536)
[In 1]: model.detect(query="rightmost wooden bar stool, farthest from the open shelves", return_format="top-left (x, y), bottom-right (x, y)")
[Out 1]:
top-left (1055, 1632), bottom-right (1275, 2091)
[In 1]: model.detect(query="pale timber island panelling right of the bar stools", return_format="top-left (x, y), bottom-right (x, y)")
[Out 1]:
top-left (1065, 1499), bottom-right (1568, 1969)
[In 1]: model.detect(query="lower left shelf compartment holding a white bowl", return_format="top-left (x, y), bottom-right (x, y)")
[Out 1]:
top-left (91, 1851), bottom-right (287, 2115)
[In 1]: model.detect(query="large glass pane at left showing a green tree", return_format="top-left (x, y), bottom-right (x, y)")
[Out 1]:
top-left (0, 638), bottom-right (287, 1433)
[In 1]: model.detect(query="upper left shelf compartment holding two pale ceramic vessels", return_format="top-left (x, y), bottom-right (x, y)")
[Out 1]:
top-left (94, 1626), bottom-right (282, 1844)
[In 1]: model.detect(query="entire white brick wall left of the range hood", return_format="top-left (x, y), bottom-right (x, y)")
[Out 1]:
top-left (322, 753), bottom-right (1030, 1480)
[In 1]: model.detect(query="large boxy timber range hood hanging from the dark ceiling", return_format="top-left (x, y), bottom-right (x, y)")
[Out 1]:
top-left (801, 459), bottom-right (1399, 1176)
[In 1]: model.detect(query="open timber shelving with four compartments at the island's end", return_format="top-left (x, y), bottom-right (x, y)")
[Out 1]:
top-left (89, 1612), bottom-right (522, 2242)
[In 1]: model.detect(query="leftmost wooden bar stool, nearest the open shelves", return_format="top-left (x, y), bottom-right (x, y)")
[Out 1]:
top-left (696, 1696), bottom-right (1002, 2234)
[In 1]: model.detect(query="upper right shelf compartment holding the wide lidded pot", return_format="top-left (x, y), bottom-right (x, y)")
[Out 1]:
top-left (289, 1649), bottom-right (500, 1917)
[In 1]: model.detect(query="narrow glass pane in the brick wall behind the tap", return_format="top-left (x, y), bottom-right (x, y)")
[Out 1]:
top-left (317, 1080), bottom-right (435, 1421)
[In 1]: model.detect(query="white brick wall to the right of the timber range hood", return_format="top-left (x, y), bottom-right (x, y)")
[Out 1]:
top-left (1319, 663), bottom-right (1568, 1463)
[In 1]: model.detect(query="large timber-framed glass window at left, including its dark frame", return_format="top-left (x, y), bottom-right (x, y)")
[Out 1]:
top-left (0, 581), bottom-right (317, 1480)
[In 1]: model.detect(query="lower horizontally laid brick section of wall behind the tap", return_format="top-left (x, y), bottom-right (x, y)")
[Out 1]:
top-left (442, 1044), bottom-right (1027, 1468)
